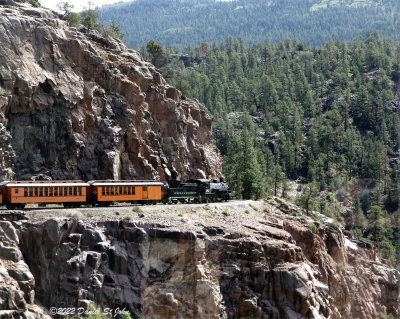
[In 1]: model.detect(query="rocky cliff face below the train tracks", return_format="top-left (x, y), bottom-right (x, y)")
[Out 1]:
top-left (0, 198), bottom-right (400, 319)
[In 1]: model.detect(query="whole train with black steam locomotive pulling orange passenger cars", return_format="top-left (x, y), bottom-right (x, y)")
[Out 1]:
top-left (0, 179), bottom-right (232, 209)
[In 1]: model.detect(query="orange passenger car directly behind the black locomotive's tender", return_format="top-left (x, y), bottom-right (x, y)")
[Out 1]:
top-left (88, 180), bottom-right (164, 206)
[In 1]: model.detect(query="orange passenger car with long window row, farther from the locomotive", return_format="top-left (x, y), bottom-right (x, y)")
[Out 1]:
top-left (0, 181), bottom-right (89, 209)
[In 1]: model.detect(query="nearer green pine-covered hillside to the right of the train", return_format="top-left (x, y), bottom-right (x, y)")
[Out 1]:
top-left (143, 32), bottom-right (400, 262)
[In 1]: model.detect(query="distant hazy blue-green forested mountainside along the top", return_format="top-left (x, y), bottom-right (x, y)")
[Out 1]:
top-left (99, 0), bottom-right (400, 48)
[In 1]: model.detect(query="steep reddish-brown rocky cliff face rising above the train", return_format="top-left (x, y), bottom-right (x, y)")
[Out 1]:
top-left (0, 0), bottom-right (221, 180)
